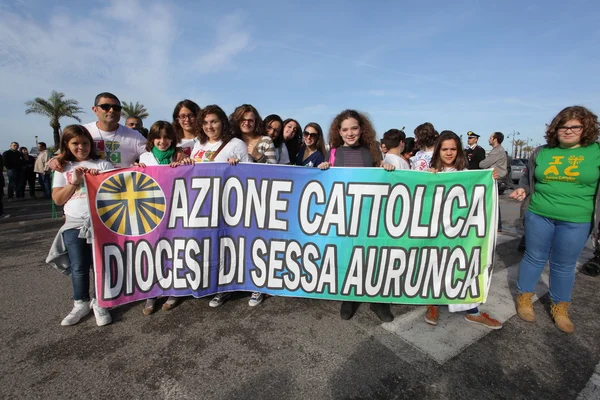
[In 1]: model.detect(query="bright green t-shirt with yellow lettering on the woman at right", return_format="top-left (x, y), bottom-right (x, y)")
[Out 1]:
top-left (529, 143), bottom-right (600, 222)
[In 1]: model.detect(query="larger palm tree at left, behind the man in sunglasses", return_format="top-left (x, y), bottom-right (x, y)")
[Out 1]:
top-left (25, 90), bottom-right (83, 148)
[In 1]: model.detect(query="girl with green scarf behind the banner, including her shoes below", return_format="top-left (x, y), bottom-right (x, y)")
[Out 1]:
top-left (134, 121), bottom-right (194, 315)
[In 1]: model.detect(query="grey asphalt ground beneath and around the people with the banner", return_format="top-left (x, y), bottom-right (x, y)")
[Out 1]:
top-left (0, 195), bottom-right (600, 399)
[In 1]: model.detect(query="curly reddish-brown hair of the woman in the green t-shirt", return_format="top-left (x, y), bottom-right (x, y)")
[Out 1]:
top-left (544, 106), bottom-right (600, 147)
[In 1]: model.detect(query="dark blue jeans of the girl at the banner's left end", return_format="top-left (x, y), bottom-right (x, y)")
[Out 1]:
top-left (63, 229), bottom-right (92, 301)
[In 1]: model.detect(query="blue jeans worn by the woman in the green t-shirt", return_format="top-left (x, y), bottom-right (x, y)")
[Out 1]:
top-left (517, 211), bottom-right (592, 303)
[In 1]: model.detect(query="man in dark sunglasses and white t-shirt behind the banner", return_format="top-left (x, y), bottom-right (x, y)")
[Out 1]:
top-left (84, 92), bottom-right (146, 168)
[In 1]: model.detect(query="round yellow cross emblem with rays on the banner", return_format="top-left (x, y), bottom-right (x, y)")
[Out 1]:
top-left (96, 171), bottom-right (166, 236)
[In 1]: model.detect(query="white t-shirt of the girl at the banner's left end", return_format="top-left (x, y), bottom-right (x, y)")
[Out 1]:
top-left (52, 160), bottom-right (113, 218)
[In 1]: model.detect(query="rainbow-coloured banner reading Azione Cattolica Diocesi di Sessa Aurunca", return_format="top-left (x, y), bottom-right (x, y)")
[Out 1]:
top-left (86, 163), bottom-right (497, 307)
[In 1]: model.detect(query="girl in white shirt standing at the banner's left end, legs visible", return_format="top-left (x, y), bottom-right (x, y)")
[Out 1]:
top-left (49, 125), bottom-right (113, 326)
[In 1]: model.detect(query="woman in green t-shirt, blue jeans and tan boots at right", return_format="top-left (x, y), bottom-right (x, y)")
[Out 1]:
top-left (510, 106), bottom-right (600, 333)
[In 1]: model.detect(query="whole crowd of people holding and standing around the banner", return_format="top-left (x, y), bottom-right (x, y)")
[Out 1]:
top-left (4, 92), bottom-right (600, 332)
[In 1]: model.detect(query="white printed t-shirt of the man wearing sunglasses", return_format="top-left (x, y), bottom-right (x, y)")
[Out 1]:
top-left (84, 122), bottom-right (146, 168)
